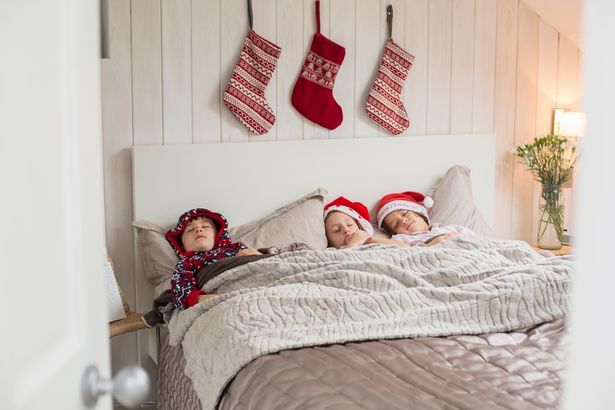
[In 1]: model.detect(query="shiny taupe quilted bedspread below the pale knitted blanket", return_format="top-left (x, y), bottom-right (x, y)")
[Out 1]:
top-left (158, 319), bottom-right (567, 410)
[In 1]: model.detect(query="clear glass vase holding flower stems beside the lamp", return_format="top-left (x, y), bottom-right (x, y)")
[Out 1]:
top-left (537, 185), bottom-right (564, 250)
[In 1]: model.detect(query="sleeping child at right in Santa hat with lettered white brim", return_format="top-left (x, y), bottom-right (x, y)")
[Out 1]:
top-left (377, 191), bottom-right (474, 246)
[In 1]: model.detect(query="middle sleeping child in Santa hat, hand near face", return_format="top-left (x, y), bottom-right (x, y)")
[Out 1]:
top-left (324, 196), bottom-right (408, 249)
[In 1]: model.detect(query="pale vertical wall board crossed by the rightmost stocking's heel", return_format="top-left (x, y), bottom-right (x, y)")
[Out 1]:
top-left (355, 1), bottom-right (386, 138)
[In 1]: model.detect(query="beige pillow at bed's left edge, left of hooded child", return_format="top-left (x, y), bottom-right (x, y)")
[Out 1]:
top-left (132, 221), bottom-right (179, 286)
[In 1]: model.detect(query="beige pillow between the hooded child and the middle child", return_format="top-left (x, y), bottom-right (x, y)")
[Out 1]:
top-left (229, 188), bottom-right (327, 249)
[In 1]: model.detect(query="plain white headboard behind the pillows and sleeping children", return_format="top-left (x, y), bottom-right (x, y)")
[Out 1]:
top-left (133, 134), bottom-right (495, 357)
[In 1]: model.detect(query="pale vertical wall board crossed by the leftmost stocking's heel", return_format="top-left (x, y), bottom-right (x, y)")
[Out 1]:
top-left (219, 0), bottom-right (249, 142)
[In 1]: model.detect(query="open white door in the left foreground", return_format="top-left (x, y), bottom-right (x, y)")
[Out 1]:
top-left (0, 0), bottom-right (111, 410)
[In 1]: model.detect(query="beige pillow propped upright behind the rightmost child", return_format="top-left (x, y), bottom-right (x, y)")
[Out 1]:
top-left (429, 165), bottom-right (494, 236)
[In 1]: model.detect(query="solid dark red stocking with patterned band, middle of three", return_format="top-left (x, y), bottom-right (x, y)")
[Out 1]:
top-left (291, 1), bottom-right (346, 130)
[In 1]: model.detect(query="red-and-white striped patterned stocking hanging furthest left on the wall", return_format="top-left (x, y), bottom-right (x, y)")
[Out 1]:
top-left (224, 2), bottom-right (282, 135)
